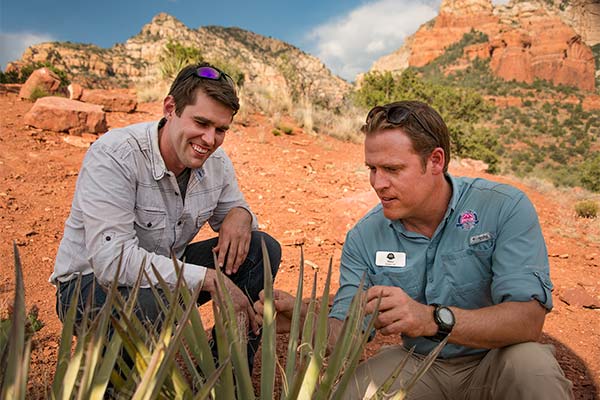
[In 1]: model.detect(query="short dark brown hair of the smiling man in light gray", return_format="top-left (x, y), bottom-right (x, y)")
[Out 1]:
top-left (169, 63), bottom-right (240, 116)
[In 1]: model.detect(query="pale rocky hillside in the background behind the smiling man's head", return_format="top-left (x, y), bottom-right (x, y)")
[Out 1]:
top-left (7, 13), bottom-right (351, 107)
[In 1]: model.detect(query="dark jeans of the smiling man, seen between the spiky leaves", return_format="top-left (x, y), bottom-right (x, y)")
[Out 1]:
top-left (56, 231), bottom-right (281, 369)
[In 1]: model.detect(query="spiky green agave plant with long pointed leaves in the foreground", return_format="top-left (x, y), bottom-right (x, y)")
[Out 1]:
top-left (0, 239), bottom-right (445, 400)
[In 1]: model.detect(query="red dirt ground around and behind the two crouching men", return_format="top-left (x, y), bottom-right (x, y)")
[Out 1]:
top-left (0, 88), bottom-right (600, 399)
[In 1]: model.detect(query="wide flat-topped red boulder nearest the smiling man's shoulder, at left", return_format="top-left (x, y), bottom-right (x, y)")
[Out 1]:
top-left (24, 96), bottom-right (107, 135)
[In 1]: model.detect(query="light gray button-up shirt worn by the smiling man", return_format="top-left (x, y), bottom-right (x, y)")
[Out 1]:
top-left (50, 122), bottom-right (258, 288)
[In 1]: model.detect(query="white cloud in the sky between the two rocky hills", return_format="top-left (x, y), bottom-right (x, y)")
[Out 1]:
top-left (308, 0), bottom-right (439, 81)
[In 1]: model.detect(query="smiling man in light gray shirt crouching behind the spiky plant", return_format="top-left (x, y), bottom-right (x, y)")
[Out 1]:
top-left (50, 64), bottom-right (281, 368)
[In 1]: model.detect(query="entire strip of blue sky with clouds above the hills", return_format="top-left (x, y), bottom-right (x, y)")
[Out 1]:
top-left (0, 0), bottom-right (460, 81)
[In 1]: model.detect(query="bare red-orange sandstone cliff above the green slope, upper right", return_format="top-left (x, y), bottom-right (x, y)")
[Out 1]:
top-left (371, 0), bottom-right (600, 92)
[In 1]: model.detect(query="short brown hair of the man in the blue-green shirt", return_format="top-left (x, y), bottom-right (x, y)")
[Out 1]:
top-left (361, 100), bottom-right (450, 172)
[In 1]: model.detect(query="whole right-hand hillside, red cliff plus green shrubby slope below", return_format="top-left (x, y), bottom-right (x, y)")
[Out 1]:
top-left (358, 0), bottom-right (600, 191)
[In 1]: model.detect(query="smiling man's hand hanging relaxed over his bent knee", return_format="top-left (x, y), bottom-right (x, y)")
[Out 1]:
top-left (213, 207), bottom-right (252, 275)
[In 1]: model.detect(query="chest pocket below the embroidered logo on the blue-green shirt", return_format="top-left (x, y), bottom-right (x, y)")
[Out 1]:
top-left (441, 239), bottom-right (494, 308)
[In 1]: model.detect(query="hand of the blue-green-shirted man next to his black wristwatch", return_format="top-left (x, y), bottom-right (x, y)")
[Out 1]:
top-left (366, 286), bottom-right (437, 337)
